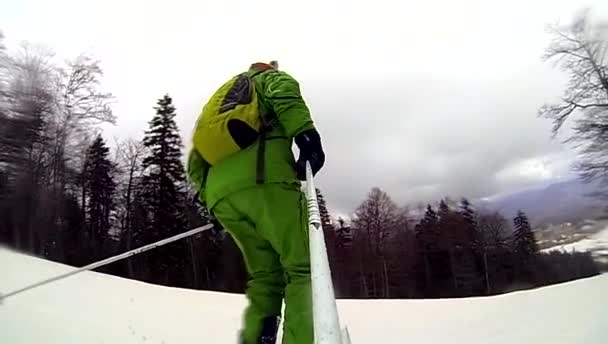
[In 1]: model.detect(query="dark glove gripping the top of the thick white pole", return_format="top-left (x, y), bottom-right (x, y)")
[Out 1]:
top-left (295, 129), bottom-right (325, 180)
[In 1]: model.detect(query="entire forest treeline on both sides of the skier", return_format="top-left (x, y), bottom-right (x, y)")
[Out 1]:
top-left (0, 36), bottom-right (598, 298)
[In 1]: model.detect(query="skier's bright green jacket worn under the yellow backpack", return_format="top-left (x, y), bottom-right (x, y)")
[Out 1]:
top-left (187, 63), bottom-right (314, 209)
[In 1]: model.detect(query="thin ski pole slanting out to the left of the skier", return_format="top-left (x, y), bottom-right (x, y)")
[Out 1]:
top-left (0, 223), bottom-right (213, 303)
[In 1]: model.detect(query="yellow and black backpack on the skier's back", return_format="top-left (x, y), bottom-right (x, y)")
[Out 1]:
top-left (192, 72), bottom-right (268, 166)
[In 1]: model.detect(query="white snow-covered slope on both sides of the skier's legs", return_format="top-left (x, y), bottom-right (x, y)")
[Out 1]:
top-left (0, 248), bottom-right (608, 344)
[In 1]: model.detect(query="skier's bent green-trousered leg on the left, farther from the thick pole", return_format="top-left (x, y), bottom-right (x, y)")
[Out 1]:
top-left (213, 195), bottom-right (284, 344)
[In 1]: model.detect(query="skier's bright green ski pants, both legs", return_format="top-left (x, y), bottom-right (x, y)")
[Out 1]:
top-left (213, 184), bottom-right (313, 344)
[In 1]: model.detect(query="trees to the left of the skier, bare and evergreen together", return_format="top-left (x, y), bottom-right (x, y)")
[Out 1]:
top-left (0, 36), bottom-right (245, 291)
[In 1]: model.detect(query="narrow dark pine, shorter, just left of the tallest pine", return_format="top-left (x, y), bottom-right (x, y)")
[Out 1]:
top-left (82, 135), bottom-right (116, 259)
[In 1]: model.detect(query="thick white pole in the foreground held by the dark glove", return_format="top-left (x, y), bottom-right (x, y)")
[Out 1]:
top-left (306, 162), bottom-right (342, 344)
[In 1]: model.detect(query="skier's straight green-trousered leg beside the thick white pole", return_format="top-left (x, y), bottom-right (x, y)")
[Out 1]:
top-left (262, 184), bottom-right (313, 344)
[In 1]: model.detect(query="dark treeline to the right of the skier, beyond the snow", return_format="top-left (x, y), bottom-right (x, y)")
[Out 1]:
top-left (326, 188), bottom-right (599, 298)
